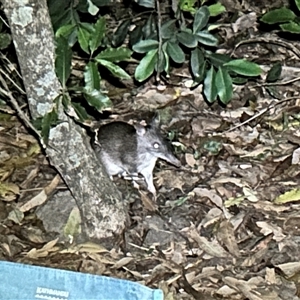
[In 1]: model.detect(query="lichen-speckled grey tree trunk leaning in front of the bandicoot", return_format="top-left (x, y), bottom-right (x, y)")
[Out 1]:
top-left (1, 0), bottom-right (127, 242)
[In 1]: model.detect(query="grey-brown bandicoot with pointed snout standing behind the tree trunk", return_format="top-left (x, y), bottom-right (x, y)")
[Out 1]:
top-left (95, 119), bottom-right (180, 195)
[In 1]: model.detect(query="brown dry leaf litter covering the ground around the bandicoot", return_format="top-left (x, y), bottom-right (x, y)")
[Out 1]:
top-left (0, 2), bottom-right (300, 300)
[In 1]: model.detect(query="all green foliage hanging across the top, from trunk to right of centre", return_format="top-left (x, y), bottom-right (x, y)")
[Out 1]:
top-left (49, 0), bottom-right (261, 113)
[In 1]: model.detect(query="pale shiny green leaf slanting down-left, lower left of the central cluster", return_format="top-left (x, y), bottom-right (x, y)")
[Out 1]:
top-left (134, 49), bottom-right (158, 82)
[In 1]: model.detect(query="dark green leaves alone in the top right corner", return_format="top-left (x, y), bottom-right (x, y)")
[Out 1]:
top-left (261, 0), bottom-right (300, 34)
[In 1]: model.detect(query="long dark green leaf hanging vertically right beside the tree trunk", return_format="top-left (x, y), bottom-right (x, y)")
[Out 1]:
top-left (55, 37), bottom-right (72, 88)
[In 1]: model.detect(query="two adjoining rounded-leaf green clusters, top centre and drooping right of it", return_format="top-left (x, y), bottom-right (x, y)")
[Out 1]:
top-left (132, 0), bottom-right (262, 104)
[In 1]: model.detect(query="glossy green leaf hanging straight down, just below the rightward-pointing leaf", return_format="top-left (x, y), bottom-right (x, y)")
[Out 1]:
top-left (215, 67), bottom-right (233, 104)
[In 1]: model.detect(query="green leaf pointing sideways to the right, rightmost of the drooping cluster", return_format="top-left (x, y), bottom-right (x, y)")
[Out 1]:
top-left (224, 59), bottom-right (262, 77)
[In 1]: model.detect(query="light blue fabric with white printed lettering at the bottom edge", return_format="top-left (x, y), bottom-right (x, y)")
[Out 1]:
top-left (0, 261), bottom-right (163, 300)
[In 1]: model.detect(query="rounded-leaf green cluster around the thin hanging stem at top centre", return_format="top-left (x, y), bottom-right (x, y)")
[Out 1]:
top-left (132, 6), bottom-right (218, 84)
